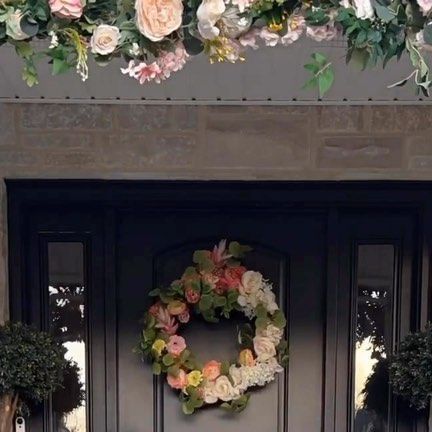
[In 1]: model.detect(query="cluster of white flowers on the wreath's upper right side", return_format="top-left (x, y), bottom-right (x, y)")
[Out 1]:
top-left (237, 271), bottom-right (279, 319)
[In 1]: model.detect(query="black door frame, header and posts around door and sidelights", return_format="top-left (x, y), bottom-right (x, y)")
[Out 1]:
top-left (6, 179), bottom-right (432, 432)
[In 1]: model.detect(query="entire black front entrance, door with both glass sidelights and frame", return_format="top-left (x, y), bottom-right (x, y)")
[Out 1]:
top-left (8, 182), bottom-right (432, 432)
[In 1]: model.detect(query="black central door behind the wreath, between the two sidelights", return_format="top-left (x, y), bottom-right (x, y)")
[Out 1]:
top-left (117, 211), bottom-right (325, 432)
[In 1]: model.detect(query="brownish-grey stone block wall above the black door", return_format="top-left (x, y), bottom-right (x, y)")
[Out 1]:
top-left (0, 104), bottom-right (432, 321)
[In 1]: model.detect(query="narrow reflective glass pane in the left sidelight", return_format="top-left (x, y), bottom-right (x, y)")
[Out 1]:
top-left (48, 242), bottom-right (87, 432)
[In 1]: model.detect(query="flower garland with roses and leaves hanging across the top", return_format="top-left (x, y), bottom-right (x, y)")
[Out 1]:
top-left (0, 0), bottom-right (432, 95)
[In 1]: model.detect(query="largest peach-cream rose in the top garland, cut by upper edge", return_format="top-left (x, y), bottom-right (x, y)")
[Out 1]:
top-left (135, 0), bottom-right (183, 42)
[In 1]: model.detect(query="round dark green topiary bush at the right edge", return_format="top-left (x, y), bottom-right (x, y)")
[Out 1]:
top-left (390, 324), bottom-right (432, 410)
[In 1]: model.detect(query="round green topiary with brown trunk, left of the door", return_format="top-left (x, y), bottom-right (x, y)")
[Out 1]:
top-left (0, 323), bottom-right (67, 432)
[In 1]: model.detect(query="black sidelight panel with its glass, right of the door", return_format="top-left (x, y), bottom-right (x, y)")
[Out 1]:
top-left (336, 211), bottom-right (416, 432)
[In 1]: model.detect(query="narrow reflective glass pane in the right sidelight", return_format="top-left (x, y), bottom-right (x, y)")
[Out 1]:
top-left (354, 245), bottom-right (395, 432)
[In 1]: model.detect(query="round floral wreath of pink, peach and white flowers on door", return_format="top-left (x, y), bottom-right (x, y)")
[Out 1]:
top-left (138, 240), bottom-right (288, 414)
